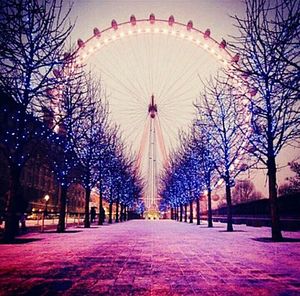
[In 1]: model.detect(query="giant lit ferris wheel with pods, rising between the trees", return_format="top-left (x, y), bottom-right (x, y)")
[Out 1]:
top-left (71, 14), bottom-right (245, 210)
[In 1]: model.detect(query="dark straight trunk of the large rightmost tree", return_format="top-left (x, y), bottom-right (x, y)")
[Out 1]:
top-left (268, 157), bottom-right (282, 241)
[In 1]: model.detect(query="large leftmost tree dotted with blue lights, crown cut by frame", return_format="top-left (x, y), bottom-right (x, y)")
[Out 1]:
top-left (0, 0), bottom-right (72, 240)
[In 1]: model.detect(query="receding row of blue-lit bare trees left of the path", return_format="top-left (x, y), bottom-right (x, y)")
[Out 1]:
top-left (0, 0), bottom-right (142, 241)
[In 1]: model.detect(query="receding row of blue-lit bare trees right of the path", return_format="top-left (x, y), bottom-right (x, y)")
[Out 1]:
top-left (161, 0), bottom-right (300, 241)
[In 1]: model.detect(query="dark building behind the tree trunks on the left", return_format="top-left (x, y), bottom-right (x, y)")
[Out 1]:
top-left (0, 90), bottom-right (85, 215)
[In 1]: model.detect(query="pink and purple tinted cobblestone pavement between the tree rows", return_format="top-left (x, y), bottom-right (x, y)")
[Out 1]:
top-left (0, 220), bottom-right (300, 296)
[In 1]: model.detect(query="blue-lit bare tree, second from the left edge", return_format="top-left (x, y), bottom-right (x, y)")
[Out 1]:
top-left (53, 70), bottom-right (95, 232)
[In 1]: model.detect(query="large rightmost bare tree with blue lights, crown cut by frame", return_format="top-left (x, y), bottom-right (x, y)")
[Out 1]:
top-left (232, 0), bottom-right (300, 241)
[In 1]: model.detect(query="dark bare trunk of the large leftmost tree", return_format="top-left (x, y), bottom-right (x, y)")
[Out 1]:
top-left (4, 167), bottom-right (22, 242)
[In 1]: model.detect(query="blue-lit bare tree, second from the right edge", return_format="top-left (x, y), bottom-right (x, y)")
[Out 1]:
top-left (197, 77), bottom-right (248, 231)
